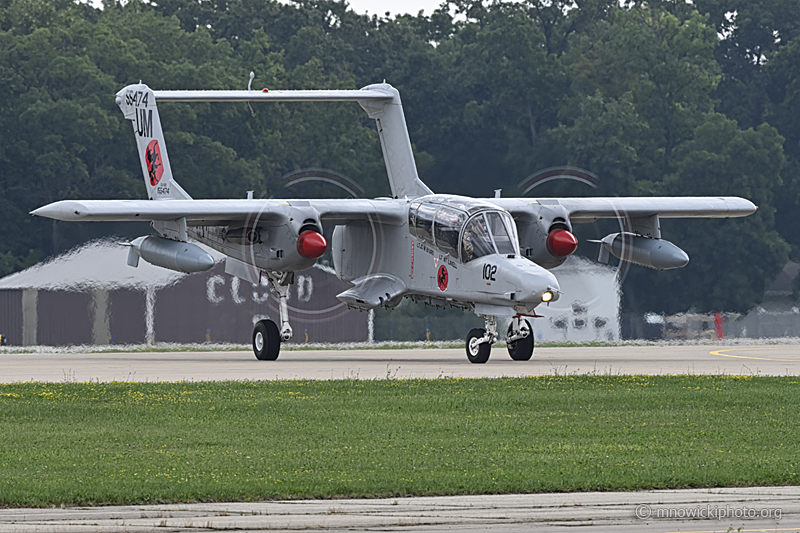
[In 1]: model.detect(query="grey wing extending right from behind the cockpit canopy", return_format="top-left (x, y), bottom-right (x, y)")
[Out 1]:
top-left (486, 196), bottom-right (758, 223)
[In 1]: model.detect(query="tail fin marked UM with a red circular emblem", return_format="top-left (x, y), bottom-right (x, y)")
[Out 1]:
top-left (116, 83), bottom-right (191, 200)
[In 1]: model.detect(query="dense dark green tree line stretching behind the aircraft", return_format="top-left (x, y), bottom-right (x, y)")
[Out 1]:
top-left (0, 0), bottom-right (800, 312)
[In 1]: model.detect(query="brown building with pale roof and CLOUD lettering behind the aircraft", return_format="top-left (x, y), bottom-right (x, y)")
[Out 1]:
top-left (0, 240), bottom-right (369, 346)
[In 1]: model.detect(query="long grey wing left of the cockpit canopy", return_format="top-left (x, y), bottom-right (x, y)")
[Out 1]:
top-left (31, 199), bottom-right (406, 226)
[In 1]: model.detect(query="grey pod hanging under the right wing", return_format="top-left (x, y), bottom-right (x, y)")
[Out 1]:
top-left (594, 233), bottom-right (689, 270)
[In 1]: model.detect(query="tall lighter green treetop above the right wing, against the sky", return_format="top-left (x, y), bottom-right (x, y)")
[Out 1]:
top-left (562, 6), bottom-right (719, 180)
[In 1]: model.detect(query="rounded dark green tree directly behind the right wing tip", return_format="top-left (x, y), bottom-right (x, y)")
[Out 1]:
top-left (626, 113), bottom-right (789, 312)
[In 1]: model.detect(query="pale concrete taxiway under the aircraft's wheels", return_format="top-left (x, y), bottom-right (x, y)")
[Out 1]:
top-left (0, 344), bottom-right (800, 383)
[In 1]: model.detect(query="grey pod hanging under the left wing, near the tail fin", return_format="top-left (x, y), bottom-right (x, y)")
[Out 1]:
top-left (128, 236), bottom-right (214, 273)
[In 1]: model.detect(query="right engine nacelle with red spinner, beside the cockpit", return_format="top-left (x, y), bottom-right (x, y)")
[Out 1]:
top-left (517, 205), bottom-right (578, 268)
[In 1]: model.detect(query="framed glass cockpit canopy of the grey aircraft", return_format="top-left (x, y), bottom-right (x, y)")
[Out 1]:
top-left (408, 195), bottom-right (519, 263)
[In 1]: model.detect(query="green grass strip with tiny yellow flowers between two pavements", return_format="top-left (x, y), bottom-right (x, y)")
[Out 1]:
top-left (0, 375), bottom-right (800, 506)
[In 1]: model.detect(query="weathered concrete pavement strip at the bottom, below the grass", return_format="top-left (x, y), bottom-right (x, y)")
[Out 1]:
top-left (0, 487), bottom-right (800, 533)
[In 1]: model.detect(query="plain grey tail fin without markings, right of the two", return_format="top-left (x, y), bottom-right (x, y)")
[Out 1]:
top-left (358, 83), bottom-right (432, 198)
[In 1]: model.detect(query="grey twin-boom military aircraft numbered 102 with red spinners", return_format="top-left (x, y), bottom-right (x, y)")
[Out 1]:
top-left (32, 80), bottom-right (757, 363)
